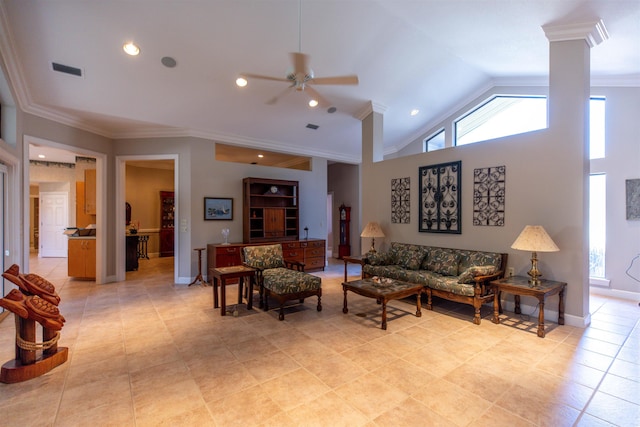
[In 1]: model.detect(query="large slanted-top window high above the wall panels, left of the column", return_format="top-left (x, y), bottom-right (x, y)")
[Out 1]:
top-left (455, 95), bottom-right (547, 145)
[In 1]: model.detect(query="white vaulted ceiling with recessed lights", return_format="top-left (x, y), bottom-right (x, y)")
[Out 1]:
top-left (0, 0), bottom-right (640, 162)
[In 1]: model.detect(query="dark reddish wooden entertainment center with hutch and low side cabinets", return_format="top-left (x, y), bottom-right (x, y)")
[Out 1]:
top-left (207, 178), bottom-right (326, 278)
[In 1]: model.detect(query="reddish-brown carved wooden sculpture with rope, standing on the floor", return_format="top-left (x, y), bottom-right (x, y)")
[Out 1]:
top-left (0, 264), bottom-right (68, 383)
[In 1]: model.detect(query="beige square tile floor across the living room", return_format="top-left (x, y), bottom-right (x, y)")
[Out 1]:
top-left (0, 258), bottom-right (640, 427)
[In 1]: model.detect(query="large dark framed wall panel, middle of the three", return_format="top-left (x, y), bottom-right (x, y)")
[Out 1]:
top-left (418, 161), bottom-right (462, 234)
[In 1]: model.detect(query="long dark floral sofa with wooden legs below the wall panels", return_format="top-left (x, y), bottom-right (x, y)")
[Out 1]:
top-left (362, 242), bottom-right (507, 325)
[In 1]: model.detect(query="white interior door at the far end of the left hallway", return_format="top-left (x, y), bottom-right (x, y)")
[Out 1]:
top-left (39, 192), bottom-right (69, 258)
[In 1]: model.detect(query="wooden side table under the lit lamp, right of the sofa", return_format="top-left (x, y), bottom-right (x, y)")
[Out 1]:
top-left (490, 276), bottom-right (567, 338)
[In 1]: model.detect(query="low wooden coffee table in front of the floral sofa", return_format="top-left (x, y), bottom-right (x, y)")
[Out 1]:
top-left (342, 279), bottom-right (423, 330)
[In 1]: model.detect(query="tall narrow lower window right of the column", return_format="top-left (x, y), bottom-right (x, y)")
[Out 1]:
top-left (589, 174), bottom-right (607, 278)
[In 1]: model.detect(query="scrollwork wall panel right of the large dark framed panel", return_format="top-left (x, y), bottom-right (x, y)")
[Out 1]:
top-left (473, 166), bottom-right (506, 226)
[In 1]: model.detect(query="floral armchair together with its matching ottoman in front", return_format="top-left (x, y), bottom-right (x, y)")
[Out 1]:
top-left (242, 244), bottom-right (322, 320)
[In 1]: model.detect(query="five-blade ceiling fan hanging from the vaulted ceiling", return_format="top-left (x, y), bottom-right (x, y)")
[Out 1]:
top-left (241, 52), bottom-right (358, 107)
